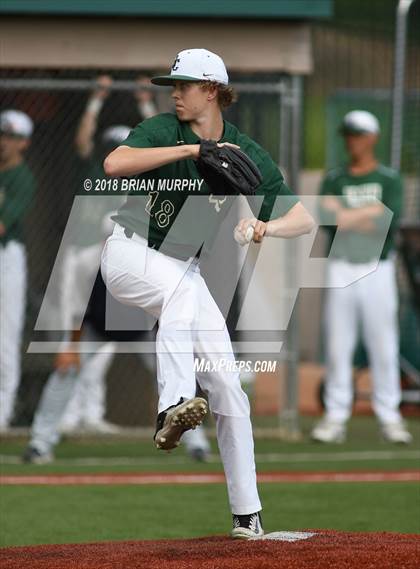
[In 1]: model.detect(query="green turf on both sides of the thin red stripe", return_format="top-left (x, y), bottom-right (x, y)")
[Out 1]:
top-left (0, 417), bottom-right (420, 546)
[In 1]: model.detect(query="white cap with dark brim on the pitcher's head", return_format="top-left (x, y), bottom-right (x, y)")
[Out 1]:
top-left (151, 49), bottom-right (229, 85)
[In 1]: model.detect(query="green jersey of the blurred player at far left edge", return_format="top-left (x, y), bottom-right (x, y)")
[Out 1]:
top-left (0, 162), bottom-right (35, 245)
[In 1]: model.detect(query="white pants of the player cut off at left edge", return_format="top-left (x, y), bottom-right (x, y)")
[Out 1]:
top-left (0, 241), bottom-right (26, 429)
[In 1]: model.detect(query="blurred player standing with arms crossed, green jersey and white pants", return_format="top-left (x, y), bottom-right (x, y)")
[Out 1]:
top-left (312, 111), bottom-right (412, 443)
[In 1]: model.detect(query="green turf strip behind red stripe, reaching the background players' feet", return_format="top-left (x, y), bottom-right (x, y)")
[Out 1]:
top-left (0, 417), bottom-right (420, 474)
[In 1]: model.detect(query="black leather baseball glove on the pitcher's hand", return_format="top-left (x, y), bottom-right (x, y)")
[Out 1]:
top-left (197, 140), bottom-right (262, 196)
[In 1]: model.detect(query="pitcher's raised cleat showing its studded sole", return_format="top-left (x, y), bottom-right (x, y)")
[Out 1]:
top-left (154, 397), bottom-right (207, 450)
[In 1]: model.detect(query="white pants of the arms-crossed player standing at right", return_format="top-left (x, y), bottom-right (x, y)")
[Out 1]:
top-left (325, 260), bottom-right (401, 423)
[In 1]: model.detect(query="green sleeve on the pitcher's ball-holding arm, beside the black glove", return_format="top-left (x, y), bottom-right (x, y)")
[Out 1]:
top-left (250, 151), bottom-right (299, 222)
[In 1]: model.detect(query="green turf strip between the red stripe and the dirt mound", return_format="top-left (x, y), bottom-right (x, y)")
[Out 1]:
top-left (0, 483), bottom-right (420, 546)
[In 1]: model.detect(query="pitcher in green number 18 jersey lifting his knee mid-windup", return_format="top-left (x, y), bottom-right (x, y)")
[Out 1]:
top-left (102, 49), bottom-right (313, 538)
